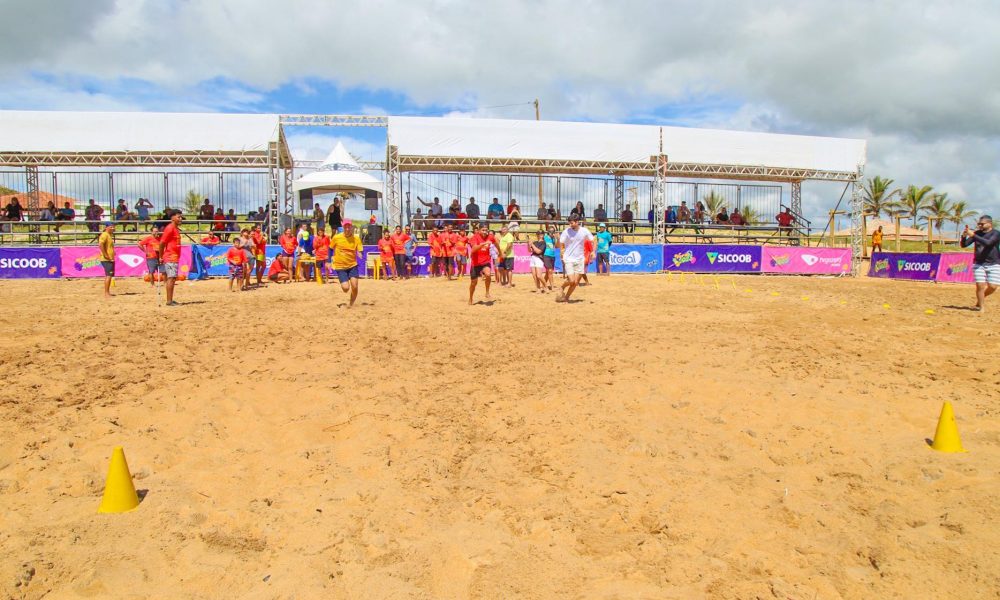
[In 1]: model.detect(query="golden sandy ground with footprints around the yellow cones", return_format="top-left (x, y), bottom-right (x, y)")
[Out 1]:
top-left (0, 275), bottom-right (1000, 600)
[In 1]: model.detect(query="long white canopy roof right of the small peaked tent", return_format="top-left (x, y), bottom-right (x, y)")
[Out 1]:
top-left (388, 117), bottom-right (866, 173)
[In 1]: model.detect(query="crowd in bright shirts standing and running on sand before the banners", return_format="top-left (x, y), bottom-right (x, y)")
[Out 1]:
top-left (92, 207), bottom-right (613, 307)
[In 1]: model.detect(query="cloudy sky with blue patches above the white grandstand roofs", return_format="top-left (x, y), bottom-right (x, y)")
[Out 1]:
top-left (0, 0), bottom-right (1000, 223)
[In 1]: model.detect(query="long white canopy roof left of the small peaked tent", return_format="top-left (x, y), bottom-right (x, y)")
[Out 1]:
top-left (0, 110), bottom-right (279, 153)
